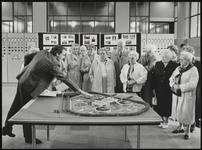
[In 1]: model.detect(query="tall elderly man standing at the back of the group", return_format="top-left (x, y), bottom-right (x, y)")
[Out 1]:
top-left (111, 39), bottom-right (129, 93)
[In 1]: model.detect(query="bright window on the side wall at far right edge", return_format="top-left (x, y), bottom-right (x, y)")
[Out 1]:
top-left (190, 2), bottom-right (201, 38)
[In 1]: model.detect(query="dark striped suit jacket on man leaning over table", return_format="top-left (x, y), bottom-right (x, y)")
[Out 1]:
top-left (16, 50), bottom-right (79, 98)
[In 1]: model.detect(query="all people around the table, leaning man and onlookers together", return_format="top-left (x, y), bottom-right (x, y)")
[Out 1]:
top-left (3, 39), bottom-right (201, 144)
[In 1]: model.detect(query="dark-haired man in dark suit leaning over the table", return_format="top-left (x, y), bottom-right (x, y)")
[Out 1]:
top-left (2, 45), bottom-right (93, 144)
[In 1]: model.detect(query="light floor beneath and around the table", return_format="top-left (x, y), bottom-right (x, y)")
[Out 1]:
top-left (2, 84), bottom-right (201, 149)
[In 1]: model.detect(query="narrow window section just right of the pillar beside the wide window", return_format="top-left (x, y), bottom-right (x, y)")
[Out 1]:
top-left (130, 2), bottom-right (149, 33)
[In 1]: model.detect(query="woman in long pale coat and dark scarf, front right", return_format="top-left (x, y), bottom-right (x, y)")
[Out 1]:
top-left (169, 51), bottom-right (199, 140)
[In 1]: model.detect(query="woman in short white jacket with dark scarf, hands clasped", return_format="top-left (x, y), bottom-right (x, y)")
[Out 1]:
top-left (120, 51), bottom-right (147, 96)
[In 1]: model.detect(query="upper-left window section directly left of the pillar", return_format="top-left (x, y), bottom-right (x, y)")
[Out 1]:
top-left (13, 2), bottom-right (33, 33)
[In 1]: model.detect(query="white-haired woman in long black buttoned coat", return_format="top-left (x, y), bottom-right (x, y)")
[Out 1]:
top-left (152, 49), bottom-right (178, 129)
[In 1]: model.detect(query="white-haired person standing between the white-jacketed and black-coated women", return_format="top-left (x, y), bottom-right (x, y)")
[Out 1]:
top-left (138, 44), bottom-right (161, 106)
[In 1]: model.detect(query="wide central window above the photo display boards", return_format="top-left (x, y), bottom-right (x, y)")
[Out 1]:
top-left (47, 2), bottom-right (115, 33)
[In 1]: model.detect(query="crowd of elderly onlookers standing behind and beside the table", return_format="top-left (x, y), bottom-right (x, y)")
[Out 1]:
top-left (51, 39), bottom-right (201, 139)
